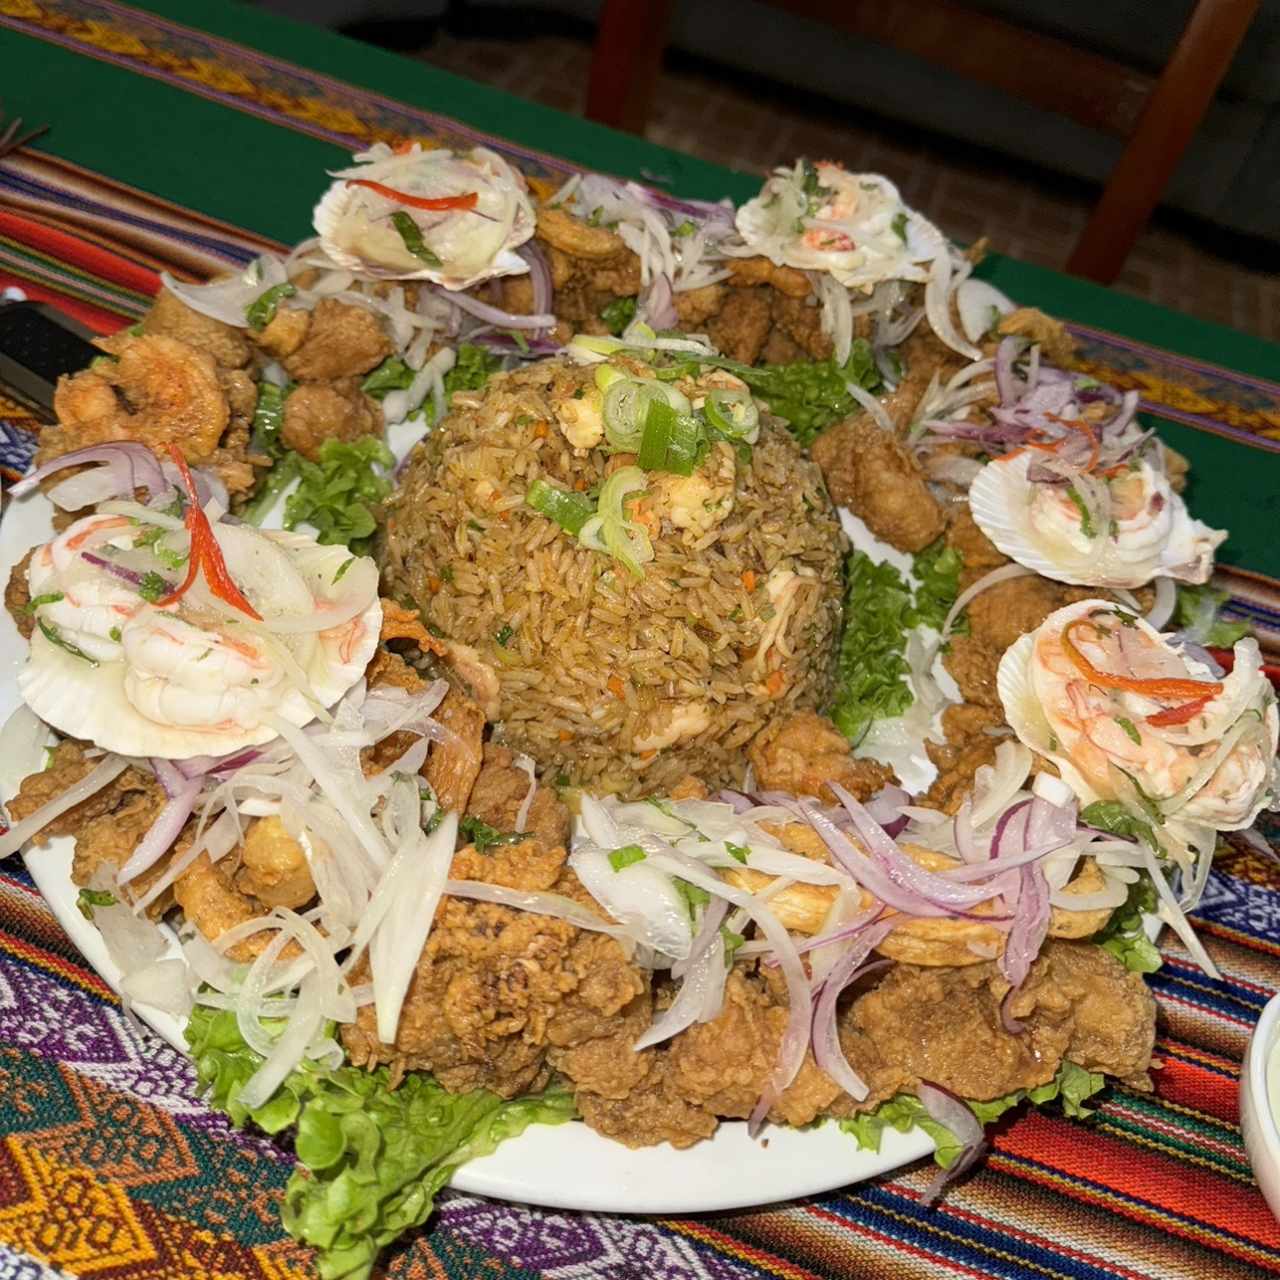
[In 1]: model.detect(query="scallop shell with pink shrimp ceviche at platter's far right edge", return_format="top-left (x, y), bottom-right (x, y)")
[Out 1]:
top-left (998, 600), bottom-right (1277, 854)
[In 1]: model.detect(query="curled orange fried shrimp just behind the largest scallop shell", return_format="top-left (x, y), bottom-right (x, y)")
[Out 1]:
top-left (37, 334), bottom-right (230, 462)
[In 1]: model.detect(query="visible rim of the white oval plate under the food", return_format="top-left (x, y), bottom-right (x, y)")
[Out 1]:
top-left (0, 481), bottom-right (933, 1213)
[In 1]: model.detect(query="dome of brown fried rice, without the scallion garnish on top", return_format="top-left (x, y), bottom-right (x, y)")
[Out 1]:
top-left (380, 360), bottom-right (846, 796)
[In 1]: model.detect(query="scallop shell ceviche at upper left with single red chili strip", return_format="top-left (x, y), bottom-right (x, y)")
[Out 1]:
top-left (314, 142), bottom-right (534, 289)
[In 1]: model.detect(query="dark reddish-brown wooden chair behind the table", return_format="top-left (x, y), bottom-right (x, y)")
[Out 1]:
top-left (586, 0), bottom-right (1260, 284)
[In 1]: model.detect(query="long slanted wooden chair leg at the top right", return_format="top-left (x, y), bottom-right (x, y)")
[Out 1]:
top-left (1066, 0), bottom-right (1260, 284)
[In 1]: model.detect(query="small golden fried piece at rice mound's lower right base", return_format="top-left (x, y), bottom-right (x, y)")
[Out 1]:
top-left (746, 712), bottom-right (896, 804)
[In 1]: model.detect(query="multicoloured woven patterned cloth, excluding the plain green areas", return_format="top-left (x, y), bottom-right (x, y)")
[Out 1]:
top-left (0, 0), bottom-right (1280, 1280)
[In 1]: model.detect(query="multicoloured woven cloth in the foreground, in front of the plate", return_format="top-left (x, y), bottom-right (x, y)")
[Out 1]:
top-left (0, 823), bottom-right (1280, 1280)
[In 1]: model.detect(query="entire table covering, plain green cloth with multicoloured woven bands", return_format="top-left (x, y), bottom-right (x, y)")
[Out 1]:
top-left (0, 0), bottom-right (1280, 1280)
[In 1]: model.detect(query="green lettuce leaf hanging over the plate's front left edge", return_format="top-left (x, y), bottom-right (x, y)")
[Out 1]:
top-left (187, 1005), bottom-right (575, 1280)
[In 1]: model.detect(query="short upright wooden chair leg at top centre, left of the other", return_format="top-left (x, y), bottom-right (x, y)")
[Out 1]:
top-left (586, 0), bottom-right (672, 136)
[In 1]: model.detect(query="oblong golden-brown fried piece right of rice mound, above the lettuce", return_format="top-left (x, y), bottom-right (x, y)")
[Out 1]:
top-left (812, 413), bottom-right (946, 552)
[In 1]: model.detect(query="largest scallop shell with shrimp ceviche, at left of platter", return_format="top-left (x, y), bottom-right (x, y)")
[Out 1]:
top-left (18, 450), bottom-right (381, 759)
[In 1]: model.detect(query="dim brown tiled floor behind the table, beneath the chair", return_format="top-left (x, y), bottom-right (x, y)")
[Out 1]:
top-left (420, 32), bottom-right (1280, 340)
